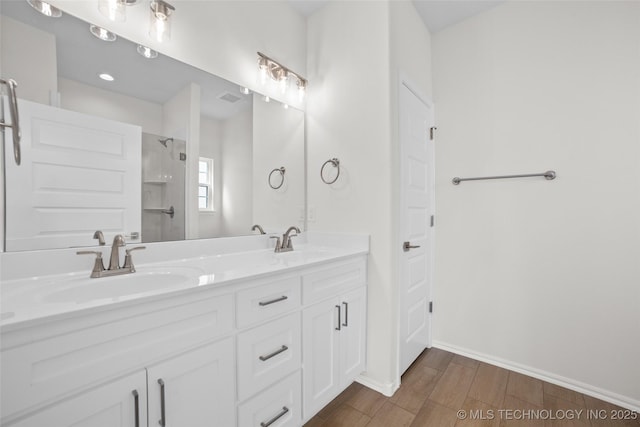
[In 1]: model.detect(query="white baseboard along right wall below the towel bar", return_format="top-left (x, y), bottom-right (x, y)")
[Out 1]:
top-left (433, 341), bottom-right (640, 412)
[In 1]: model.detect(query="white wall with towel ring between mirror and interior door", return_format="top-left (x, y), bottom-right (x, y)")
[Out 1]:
top-left (306, 1), bottom-right (396, 389)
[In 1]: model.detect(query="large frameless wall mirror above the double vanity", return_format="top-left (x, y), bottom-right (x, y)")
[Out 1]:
top-left (0, 1), bottom-right (305, 251)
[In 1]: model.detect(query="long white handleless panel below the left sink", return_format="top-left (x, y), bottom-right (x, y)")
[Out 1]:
top-left (0, 295), bottom-right (233, 420)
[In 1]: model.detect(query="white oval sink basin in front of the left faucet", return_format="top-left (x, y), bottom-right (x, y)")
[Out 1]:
top-left (43, 268), bottom-right (201, 303)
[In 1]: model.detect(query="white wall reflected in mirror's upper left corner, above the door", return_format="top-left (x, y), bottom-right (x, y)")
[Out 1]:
top-left (0, 16), bottom-right (58, 105)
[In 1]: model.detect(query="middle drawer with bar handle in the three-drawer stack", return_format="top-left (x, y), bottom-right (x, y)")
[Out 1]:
top-left (237, 312), bottom-right (301, 400)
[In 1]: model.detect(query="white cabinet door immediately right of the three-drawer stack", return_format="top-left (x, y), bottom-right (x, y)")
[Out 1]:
top-left (302, 299), bottom-right (341, 419)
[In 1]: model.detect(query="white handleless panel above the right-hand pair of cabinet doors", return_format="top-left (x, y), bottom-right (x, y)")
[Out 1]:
top-left (302, 259), bottom-right (367, 305)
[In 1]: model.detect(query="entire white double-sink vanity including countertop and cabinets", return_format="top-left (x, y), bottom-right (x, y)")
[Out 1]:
top-left (0, 233), bottom-right (368, 427)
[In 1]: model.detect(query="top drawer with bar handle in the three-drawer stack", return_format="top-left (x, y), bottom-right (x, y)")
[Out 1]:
top-left (236, 277), bottom-right (300, 328)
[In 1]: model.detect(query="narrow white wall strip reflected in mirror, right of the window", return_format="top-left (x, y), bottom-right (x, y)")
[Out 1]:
top-left (218, 109), bottom-right (253, 236)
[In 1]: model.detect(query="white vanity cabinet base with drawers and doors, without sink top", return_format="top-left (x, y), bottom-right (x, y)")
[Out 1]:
top-left (0, 254), bottom-right (366, 427)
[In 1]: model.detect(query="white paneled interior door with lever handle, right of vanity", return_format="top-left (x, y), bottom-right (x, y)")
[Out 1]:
top-left (398, 84), bottom-right (434, 374)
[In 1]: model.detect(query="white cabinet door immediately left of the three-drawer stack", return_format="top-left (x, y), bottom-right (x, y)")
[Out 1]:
top-left (147, 338), bottom-right (235, 427)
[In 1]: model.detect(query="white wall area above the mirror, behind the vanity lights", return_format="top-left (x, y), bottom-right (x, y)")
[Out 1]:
top-left (50, 0), bottom-right (306, 110)
